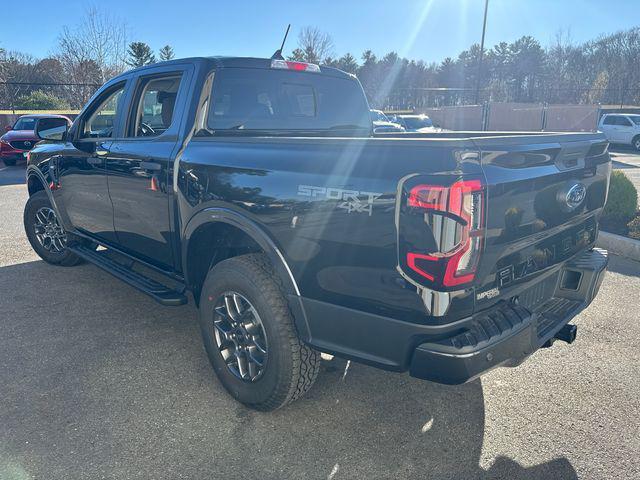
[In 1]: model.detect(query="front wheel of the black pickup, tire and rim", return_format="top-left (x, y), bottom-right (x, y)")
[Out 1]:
top-left (24, 190), bottom-right (82, 267)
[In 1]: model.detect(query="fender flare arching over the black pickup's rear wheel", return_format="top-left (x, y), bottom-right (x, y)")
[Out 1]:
top-left (181, 207), bottom-right (300, 297)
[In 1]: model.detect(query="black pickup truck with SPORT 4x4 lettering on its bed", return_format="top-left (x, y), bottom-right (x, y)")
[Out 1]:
top-left (24, 57), bottom-right (611, 410)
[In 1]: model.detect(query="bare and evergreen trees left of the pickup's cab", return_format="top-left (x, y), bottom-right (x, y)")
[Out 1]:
top-left (0, 7), bottom-right (174, 110)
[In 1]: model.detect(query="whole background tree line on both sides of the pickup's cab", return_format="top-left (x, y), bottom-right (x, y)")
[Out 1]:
top-left (0, 13), bottom-right (640, 109)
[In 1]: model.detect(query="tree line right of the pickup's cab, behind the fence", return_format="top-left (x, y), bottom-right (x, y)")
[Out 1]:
top-left (289, 27), bottom-right (640, 109)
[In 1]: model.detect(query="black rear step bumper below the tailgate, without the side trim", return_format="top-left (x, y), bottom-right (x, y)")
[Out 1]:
top-left (409, 249), bottom-right (608, 384)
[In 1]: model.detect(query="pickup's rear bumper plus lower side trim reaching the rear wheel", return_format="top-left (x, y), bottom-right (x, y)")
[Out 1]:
top-left (298, 249), bottom-right (608, 384)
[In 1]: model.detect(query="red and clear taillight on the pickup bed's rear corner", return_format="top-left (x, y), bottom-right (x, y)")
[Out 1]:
top-left (406, 180), bottom-right (485, 287)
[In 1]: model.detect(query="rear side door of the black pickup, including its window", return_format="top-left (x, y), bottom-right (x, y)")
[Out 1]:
top-left (106, 67), bottom-right (187, 269)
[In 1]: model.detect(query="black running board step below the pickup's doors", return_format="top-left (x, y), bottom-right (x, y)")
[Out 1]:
top-left (67, 245), bottom-right (187, 307)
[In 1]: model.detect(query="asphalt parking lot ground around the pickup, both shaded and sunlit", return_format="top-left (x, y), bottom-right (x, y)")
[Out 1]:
top-left (0, 164), bottom-right (640, 480)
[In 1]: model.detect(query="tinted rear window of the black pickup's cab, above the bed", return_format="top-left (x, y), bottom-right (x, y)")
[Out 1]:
top-left (207, 68), bottom-right (371, 135)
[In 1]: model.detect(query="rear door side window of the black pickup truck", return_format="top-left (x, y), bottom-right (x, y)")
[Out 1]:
top-left (127, 73), bottom-right (182, 137)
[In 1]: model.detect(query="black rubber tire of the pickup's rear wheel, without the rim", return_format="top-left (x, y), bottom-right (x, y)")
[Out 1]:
top-left (199, 254), bottom-right (320, 411)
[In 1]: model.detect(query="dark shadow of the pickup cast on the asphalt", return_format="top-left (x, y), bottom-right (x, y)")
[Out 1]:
top-left (0, 261), bottom-right (577, 479)
